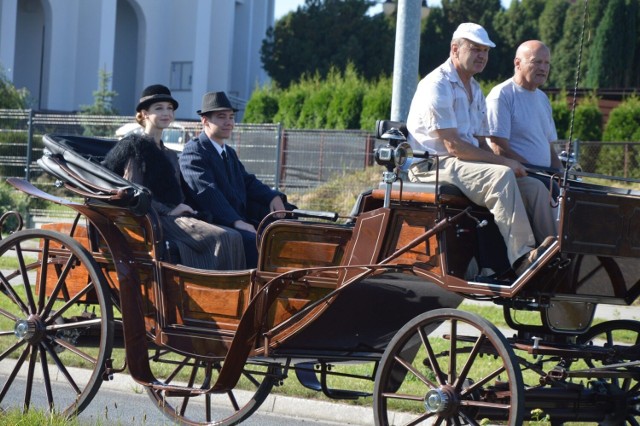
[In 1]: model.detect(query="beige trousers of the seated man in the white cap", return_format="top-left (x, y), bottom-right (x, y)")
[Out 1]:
top-left (409, 157), bottom-right (557, 265)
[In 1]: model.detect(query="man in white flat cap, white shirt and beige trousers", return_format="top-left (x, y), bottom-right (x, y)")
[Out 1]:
top-left (407, 22), bottom-right (556, 275)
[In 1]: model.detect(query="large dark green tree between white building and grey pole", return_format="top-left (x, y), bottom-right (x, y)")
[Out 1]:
top-left (260, 0), bottom-right (395, 88)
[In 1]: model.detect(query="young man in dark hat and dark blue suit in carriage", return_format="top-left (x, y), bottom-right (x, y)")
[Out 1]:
top-left (180, 92), bottom-right (286, 268)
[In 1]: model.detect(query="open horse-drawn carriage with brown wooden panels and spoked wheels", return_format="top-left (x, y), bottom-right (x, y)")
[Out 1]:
top-left (0, 122), bottom-right (640, 425)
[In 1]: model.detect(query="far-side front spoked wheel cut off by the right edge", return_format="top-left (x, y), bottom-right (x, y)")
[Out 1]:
top-left (578, 320), bottom-right (640, 426)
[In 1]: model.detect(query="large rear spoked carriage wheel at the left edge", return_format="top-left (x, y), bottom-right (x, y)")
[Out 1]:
top-left (0, 230), bottom-right (113, 416)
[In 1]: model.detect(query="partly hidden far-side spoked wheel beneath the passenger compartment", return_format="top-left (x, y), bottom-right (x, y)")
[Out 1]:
top-left (147, 348), bottom-right (283, 425)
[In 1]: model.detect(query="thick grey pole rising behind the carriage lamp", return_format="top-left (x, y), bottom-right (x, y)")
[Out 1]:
top-left (391, 0), bottom-right (422, 121)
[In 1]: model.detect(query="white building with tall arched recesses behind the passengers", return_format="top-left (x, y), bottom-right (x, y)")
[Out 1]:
top-left (0, 0), bottom-right (275, 118)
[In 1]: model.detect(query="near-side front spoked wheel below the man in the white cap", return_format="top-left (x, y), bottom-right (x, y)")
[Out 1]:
top-left (373, 309), bottom-right (524, 426)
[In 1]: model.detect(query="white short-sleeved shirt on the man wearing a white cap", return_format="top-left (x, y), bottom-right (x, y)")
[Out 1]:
top-left (407, 59), bottom-right (489, 155)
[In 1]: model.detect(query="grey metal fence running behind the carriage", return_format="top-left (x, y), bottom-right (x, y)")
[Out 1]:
top-left (0, 109), bottom-right (640, 220)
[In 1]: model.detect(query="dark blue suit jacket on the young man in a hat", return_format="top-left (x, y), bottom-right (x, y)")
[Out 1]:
top-left (180, 132), bottom-right (283, 228)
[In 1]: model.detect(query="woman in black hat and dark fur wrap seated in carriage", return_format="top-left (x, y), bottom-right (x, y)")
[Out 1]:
top-left (104, 84), bottom-right (246, 270)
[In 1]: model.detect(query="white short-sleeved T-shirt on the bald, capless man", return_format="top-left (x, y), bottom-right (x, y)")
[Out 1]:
top-left (487, 78), bottom-right (558, 167)
